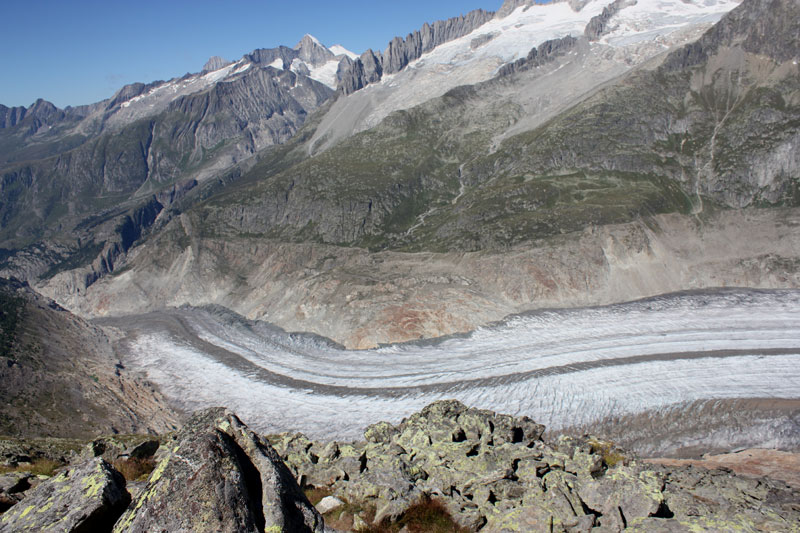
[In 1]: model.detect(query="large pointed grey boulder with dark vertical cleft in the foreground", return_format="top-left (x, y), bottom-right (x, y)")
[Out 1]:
top-left (114, 408), bottom-right (324, 533)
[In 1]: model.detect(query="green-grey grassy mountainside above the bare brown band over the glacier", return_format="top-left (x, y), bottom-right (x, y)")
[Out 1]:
top-left (172, 0), bottom-right (798, 251)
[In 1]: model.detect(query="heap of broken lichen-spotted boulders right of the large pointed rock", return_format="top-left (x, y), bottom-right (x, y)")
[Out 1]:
top-left (272, 401), bottom-right (800, 532)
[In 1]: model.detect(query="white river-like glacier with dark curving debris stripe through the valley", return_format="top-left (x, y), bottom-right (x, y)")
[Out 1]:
top-left (120, 291), bottom-right (800, 438)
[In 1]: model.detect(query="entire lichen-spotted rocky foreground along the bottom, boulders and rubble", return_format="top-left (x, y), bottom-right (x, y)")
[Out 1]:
top-left (0, 401), bottom-right (800, 533)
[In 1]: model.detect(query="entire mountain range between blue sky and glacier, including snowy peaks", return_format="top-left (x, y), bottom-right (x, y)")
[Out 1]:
top-left (0, 0), bottom-right (800, 348)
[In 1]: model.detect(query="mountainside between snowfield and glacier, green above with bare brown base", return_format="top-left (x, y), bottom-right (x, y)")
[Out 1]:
top-left (51, 1), bottom-right (800, 347)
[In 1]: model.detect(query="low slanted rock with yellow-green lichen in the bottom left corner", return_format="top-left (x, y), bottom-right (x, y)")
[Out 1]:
top-left (0, 458), bottom-right (130, 533)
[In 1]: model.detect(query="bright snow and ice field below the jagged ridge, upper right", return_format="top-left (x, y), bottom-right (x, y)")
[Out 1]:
top-left (310, 0), bottom-right (738, 152)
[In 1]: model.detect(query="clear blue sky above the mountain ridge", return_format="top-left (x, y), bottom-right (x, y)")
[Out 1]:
top-left (0, 0), bottom-right (502, 107)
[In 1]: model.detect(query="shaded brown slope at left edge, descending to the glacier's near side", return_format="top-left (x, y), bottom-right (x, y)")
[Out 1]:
top-left (0, 279), bottom-right (178, 437)
